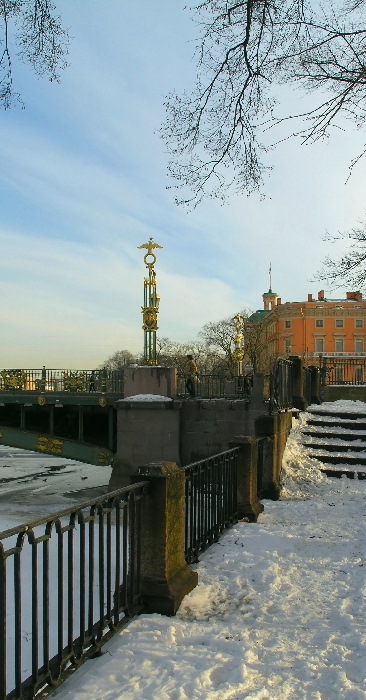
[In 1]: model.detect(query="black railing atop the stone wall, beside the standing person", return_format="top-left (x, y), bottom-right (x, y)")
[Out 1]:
top-left (177, 374), bottom-right (253, 401)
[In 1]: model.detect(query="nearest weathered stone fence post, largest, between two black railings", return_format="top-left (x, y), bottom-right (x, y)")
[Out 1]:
top-left (131, 462), bottom-right (198, 615)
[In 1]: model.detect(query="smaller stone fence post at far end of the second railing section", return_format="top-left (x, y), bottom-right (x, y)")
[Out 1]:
top-left (230, 435), bottom-right (263, 523)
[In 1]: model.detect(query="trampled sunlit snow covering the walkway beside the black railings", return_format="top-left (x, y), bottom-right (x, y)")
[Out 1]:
top-left (55, 402), bottom-right (366, 700)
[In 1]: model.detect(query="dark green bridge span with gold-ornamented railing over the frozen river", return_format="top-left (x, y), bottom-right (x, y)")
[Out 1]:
top-left (0, 367), bottom-right (124, 465)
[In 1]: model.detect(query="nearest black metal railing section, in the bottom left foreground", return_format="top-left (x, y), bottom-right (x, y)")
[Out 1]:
top-left (0, 482), bottom-right (148, 700)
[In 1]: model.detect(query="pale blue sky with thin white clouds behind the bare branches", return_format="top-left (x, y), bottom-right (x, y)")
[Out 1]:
top-left (0, 0), bottom-right (366, 369)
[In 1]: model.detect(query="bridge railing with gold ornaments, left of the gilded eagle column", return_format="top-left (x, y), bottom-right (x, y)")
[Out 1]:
top-left (0, 367), bottom-right (124, 396)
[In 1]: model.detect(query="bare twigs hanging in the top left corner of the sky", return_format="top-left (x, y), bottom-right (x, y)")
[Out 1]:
top-left (0, 0), bottom-right (69, 109)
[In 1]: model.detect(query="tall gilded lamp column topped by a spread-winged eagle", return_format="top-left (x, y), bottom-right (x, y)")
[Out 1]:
top-left (137, 238), bottom-right (163, 365)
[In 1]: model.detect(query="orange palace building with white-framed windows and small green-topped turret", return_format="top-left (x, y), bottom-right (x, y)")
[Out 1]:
top-left (253, 289), bottom-right (366, 364)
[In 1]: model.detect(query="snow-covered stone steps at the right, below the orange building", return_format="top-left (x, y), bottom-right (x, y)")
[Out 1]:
top-left (302, 401), bottom-right (366, 479)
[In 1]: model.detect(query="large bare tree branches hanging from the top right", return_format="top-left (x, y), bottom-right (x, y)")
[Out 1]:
top-left (161, 0), bottom-right (366, 205)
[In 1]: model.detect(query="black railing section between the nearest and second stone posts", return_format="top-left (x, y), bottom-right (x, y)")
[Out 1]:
top-left (184, 448), bottom-right (239, 563)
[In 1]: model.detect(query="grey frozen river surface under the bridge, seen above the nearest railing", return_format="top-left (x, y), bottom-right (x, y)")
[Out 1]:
top-left (0, 445), bottom-right (111, 530)
